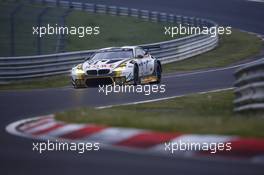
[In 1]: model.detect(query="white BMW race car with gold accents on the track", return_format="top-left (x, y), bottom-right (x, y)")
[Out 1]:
top-left (71, 46), bottom-right (162, 88)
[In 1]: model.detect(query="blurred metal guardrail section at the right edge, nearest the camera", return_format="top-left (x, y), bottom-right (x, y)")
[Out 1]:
top-left (234, 58), bottom-right (264, 112)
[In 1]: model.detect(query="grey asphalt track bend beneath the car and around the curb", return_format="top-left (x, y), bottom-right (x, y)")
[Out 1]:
top-left (0, 65), bottom-right (264, 175)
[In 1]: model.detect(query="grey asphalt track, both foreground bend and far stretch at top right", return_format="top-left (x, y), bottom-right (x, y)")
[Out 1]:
top-left (0, 0), bottom-right (264, 175)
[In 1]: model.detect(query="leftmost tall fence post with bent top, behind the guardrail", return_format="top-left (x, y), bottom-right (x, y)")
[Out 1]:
top-left (10, 4), bottom-right (23, 56)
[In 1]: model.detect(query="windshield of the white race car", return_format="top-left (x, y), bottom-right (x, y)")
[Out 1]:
top-left (91, 50), bottom-right (133, 60)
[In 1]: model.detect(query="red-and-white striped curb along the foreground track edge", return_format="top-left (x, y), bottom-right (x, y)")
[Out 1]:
top-left (6, 115), bottom-right (264, 163)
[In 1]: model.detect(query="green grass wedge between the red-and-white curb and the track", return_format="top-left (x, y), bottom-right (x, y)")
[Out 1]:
top-left (56, 91), bottom-right (264, 137)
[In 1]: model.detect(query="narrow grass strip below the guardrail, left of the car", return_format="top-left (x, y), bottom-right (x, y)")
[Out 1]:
top-left (0, 75), bottom-right (71, 90)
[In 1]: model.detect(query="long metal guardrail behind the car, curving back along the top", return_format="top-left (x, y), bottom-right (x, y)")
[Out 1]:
top-left (0, 0), bottom-right (218, 83)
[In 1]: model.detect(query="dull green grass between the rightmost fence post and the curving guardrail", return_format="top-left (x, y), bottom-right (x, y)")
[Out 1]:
top-left (67, 11), bottom-right (172, 51)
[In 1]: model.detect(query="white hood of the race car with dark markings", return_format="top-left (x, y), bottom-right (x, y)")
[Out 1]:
top-left (82, 58), bottom-right (131, 71)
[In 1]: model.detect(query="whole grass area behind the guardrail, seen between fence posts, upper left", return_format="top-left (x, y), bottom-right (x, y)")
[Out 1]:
top-left (0, 0), bottom-right (171, 56)
